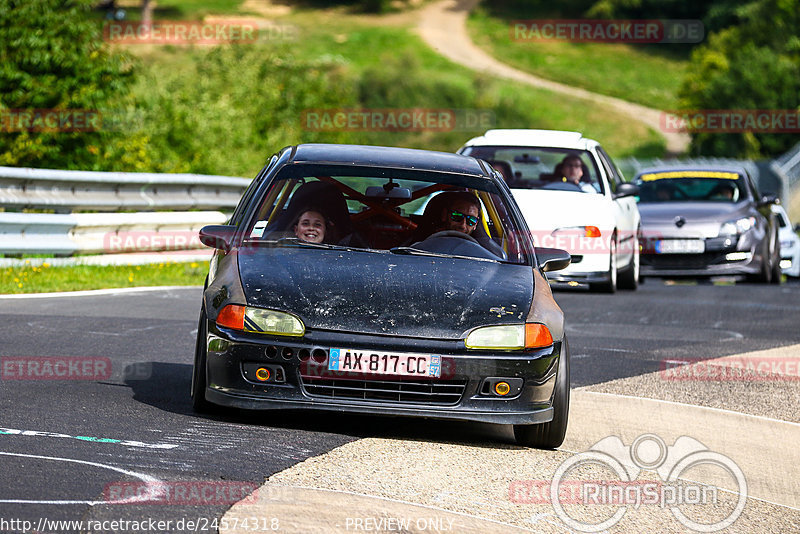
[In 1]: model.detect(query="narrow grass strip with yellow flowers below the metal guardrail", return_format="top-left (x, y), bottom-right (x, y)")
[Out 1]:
top-left (0, 262), bottom-right (208, 295)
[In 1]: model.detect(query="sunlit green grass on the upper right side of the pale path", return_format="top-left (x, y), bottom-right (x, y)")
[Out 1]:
top-left (467, 4), bottom-right (688, 109)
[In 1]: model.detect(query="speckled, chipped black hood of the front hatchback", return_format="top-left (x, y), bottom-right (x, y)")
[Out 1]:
top-left (239, 247), bottom-right (533, 339)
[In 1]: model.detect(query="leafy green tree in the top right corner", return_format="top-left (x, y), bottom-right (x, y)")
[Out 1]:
top-left (680, 0), bottom-right (800, 158)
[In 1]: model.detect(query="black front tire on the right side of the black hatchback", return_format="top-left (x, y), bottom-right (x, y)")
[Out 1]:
top-left (514, 336), bottom-right (569, 449)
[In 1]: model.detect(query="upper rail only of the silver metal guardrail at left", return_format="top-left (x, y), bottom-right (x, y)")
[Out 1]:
top-left (0, 167), bottom-right (250, 213)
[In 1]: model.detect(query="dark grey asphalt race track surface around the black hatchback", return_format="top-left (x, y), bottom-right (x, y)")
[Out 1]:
top-left (0, 279), bottom-right (800, 532)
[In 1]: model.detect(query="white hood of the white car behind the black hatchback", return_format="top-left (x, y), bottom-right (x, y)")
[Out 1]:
top-left (511, 189), bottom-right (614, 237)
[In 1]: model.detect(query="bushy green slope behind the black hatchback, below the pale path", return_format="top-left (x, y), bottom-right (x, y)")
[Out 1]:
top-left (123, 11), bottom-right (664, 176)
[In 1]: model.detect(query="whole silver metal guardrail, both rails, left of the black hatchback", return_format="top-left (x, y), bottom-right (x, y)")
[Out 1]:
top-left (0, 167), bottom-right (250, 256)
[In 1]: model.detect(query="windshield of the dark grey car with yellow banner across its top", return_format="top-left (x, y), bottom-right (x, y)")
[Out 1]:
top-left (636, 171), bottom-right (746, 203)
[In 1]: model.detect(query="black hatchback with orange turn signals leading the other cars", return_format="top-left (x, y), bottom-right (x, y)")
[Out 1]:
top-left (191, 144), bottom-right (569, 448)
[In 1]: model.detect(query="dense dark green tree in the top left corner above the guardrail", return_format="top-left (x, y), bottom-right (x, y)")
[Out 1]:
top-left (0, 0), bottom-right (133, 169)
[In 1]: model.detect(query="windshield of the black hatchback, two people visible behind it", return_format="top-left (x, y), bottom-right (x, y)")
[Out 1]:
top-left (245, 165), bottom-right (530, 264)
